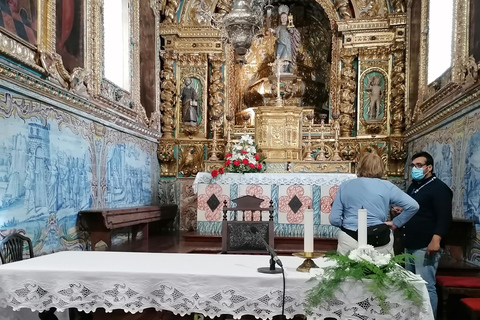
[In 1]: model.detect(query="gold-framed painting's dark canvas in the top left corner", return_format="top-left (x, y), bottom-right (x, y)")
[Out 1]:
top-left (0, 0), bottom-right (38, 46)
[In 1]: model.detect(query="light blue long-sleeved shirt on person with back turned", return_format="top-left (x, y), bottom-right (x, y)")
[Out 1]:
top-left (329, 178), bottom-right (419, 231)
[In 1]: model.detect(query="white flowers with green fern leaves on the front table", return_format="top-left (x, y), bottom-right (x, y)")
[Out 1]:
top-left (306, 245), bottom-right (423, 312)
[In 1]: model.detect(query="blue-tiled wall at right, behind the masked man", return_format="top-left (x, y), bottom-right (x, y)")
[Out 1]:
top-left (408, 106), bottom-right (480, 265)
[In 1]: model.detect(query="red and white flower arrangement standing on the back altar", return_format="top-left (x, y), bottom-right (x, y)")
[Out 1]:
top-left (211, 134), bottom-right (265, 178)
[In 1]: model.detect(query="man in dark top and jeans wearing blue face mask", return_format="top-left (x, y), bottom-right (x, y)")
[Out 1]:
top-left (392, 152), bottom-right (453, 316)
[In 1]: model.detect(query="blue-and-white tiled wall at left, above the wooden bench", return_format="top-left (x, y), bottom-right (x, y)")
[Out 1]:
top-left (0, 87), bottom-right (159, 255)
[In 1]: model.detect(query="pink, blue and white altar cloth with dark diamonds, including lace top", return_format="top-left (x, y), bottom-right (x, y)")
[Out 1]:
top-left (193, 172), bottom-right (357, 238)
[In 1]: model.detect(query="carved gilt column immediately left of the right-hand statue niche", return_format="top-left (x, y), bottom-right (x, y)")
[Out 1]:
top-left (338, 49), bottom-right (358, 137)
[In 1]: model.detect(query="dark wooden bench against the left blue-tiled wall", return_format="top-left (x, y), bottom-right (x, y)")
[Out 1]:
top-left (78, 204), bottom-right (177, 250)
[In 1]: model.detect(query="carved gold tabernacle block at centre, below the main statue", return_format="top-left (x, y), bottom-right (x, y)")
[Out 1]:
top-left (255, 106), bottom-right (303, 161)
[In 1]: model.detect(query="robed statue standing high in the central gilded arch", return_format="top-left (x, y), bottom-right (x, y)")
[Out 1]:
top-left (270, 5), bottom-right (300, 73)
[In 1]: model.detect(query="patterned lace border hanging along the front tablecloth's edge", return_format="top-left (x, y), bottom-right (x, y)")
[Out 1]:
top-left (0, 279), bottom-right (433, 320)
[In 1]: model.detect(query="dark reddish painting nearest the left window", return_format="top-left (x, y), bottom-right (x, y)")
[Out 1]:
top-left (56, 0), bottom-right (85, 72)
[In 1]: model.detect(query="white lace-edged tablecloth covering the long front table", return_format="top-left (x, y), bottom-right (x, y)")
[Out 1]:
top-left (0, 251), bottom-right (433, 320)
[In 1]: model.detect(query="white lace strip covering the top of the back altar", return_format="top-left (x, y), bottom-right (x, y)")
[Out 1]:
top-left (193, 172), bottom-right (357, 193)
